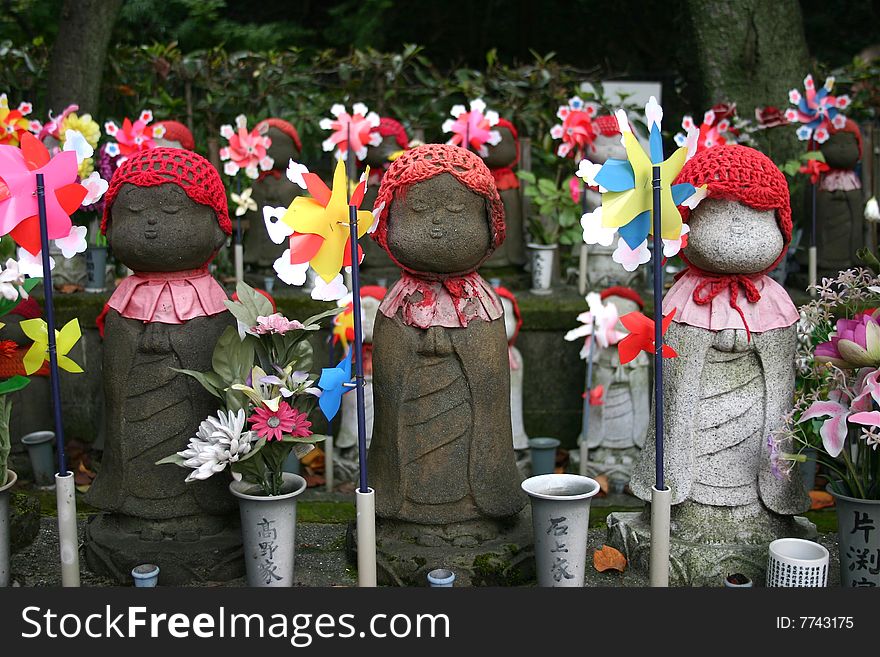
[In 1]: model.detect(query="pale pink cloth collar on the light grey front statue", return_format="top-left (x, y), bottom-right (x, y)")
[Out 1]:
top-left (663, 270), bottom-right (800, 333)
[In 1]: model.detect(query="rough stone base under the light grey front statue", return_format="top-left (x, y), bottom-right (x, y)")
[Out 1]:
top-left (607, 503), bottom-right (817, 586)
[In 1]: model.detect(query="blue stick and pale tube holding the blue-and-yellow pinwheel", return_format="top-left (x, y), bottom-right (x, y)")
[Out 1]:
top-left (650, 165), bottom-right (672, 586)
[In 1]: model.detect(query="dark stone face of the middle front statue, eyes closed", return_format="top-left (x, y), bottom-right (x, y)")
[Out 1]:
top-left (388, 173), bottom-right (492, 274)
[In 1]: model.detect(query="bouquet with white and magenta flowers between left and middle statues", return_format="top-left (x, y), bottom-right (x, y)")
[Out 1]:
top-left (157, 283), bottom-right (340, 496)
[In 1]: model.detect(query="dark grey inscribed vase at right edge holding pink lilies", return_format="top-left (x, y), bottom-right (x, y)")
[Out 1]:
top-left (825, 484), bottom-right (880, 588)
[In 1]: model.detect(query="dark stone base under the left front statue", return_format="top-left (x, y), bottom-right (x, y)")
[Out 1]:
top-left (85, 514), bottom-right (244, 586)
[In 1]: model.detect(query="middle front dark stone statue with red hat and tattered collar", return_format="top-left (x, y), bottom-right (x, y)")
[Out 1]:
top-left (369, 144), bottom-right (525, 532)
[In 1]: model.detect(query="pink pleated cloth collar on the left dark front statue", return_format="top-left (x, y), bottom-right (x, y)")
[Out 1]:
top-left (107, 267), bottom-right (228, 324)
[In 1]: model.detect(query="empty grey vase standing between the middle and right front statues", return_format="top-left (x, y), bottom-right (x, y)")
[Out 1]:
top-left (522, 474), bottom-right (599, 587)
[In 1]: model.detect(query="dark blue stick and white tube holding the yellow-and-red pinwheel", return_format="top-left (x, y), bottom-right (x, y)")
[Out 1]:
top-left (348, 205), bottom-right (376, 587)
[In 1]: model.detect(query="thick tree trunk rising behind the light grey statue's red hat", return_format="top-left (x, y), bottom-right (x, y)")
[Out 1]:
top-left (686, 0), bottom-right (821, 162)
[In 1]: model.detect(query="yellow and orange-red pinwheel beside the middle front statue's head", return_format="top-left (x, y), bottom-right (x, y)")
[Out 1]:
top-left (281, 160), bottom-right (373, 283)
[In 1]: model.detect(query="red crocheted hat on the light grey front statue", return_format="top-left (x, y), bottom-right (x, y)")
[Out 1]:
top-left (674, 145), bottom-right (792, 274)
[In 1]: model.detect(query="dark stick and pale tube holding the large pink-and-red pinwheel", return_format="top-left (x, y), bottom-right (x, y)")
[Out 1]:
top-left (37, 173), bottom-right (79, 586)
